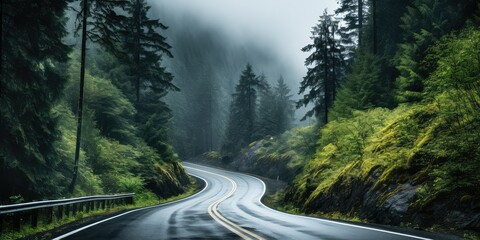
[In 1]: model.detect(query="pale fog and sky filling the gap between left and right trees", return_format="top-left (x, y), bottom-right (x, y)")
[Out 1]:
top-left (146, 0), bottom-right (336, 157)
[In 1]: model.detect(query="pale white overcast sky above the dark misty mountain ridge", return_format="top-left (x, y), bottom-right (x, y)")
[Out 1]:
top-left (149, 0), bottom-right (337, 84)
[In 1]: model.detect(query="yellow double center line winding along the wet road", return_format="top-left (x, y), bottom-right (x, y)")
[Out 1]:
top-left (183, 166), bottom-right (265, 240)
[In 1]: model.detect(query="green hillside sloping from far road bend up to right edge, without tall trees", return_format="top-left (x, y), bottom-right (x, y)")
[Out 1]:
top-left (198, 29), bottom-right (480, 236)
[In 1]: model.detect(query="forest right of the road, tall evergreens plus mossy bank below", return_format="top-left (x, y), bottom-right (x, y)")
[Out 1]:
top-left (196, 0), bottom-right (480, 234)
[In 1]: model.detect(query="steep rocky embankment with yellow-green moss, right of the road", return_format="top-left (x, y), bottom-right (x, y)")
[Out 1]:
top-left (283, 104), bottom-right (480, 230)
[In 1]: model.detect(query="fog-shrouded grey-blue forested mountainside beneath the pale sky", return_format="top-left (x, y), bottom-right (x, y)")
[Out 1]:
top-left (158, 14), bottom-right (296, 159)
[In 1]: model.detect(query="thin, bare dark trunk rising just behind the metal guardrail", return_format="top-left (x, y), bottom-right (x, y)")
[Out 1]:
top-left (70, 0), bottom-right (88, 193)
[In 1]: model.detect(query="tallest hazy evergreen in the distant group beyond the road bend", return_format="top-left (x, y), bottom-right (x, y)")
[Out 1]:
top-left (222, 64), bottom-right (262, 154)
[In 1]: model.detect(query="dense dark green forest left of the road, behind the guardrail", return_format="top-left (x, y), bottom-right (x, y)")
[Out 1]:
top-left (0, 0), bottom-right (189, 203)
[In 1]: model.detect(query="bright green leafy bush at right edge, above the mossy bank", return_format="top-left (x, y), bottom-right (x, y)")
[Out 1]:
top-left (425, 28), bottom-right (480, 125)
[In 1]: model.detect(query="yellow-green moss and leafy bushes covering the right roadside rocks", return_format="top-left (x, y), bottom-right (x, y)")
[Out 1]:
top-left (283, 28), bottom-right (480, 231)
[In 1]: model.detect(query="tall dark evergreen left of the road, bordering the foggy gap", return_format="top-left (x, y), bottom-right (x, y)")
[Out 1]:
top-left (121, 0), bottom-right (179, 158)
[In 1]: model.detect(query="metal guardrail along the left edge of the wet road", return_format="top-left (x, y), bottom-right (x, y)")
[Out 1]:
top-left (0, 193), bottom-right (135, 233)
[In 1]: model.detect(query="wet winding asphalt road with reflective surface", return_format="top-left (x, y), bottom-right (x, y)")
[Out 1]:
top-left (54, 162), bottom-right (446, 240)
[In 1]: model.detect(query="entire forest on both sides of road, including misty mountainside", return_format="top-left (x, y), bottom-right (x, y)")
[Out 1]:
top-left (0, 0), bottom-right (480, 236)
